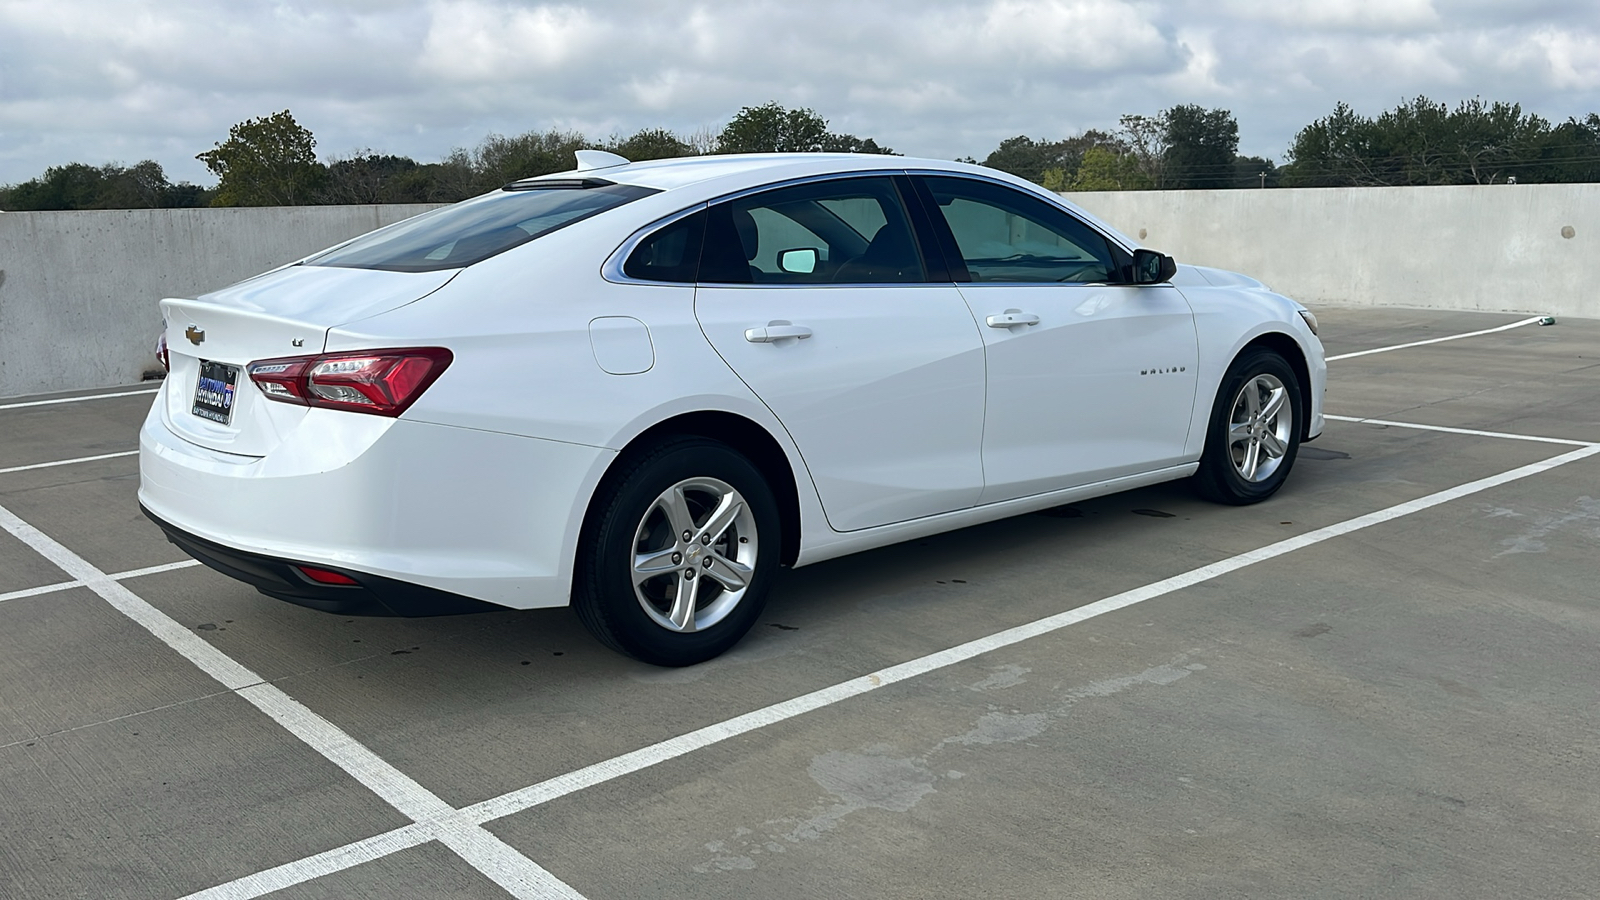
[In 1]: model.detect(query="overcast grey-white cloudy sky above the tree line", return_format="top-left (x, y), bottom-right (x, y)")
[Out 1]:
top-left (0, 0), bottom-right (1600, 184)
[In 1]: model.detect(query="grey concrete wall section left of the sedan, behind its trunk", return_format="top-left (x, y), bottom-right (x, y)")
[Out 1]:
top-left (0, 205), bottom-right (434, 397)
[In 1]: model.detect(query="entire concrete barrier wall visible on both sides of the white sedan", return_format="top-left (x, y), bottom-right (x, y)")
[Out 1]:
top-left (0, 184), bottom-right (1600, 397)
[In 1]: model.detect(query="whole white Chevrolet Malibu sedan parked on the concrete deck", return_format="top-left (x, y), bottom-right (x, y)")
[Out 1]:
top-left (139, 151), bottom-right (1326, 666)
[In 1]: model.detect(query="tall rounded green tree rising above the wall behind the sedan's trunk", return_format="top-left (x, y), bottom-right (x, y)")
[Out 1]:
top-left (195, 109), bottom-right (326, 207)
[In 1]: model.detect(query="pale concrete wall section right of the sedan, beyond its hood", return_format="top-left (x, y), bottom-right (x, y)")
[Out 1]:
top-left (1064, 184), bottom-right (1600, 319)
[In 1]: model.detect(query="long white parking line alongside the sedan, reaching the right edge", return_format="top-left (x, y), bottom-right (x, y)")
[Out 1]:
top-left (172, 432), bottom-right (1600, 900)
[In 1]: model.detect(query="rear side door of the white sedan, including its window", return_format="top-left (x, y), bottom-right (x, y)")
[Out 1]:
top-left (694, 176), bottom-right (984, 532)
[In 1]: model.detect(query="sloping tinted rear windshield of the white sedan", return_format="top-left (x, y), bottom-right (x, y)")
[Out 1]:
top-left (307, 184), bottom-right (656, 272)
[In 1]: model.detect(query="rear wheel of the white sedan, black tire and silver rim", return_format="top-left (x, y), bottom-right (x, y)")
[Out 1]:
top-left (573, 437), bottom-right (782, 666)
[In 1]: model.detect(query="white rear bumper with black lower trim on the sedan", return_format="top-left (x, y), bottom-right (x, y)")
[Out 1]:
top-left (139, 385), bottom-right (614, 615)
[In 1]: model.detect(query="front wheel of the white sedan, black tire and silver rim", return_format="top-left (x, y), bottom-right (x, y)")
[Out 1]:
top-left (1192, 348), bottom-right (1304, 506)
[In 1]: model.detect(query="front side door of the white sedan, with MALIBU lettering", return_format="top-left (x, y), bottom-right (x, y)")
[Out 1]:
top-left (920, 175), bottom-right (1198, 503)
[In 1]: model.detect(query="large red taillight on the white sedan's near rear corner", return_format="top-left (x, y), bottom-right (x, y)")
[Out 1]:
top-left (250, 348), bottom-right (454, 416)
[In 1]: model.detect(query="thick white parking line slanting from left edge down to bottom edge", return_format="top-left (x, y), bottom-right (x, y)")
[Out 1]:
top-left (0, 506), bottom-right (582, 900)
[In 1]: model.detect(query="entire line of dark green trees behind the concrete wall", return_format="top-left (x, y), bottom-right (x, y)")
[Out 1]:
top-left (0, 96), bottom-right (1600, 210)
